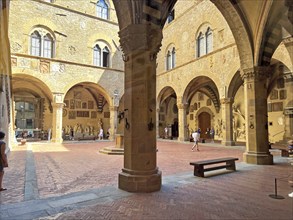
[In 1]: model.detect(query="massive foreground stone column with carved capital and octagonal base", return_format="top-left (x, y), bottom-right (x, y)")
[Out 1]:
top-left (118, 24), bottom-right (162, 192)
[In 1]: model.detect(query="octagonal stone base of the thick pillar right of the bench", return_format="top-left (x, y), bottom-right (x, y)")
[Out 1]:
top-left (243, 152), bottom-right (274, 165)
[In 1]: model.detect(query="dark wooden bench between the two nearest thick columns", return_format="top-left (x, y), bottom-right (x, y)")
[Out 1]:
top-left (190, 157), bottom-right (238, 177)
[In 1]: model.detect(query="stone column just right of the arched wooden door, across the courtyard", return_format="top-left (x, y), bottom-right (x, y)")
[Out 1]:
top-left (221, 98), bottom-right (235, 146)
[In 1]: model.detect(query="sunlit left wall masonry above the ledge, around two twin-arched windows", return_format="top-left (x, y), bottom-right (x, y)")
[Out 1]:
top-left (9, 1), bottom-right (123, 70)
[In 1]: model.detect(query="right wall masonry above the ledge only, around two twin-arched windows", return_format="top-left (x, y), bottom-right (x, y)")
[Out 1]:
top-left (157, 1), bottom-right (237, 77)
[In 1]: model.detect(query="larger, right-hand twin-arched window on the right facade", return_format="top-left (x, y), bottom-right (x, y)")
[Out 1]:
top-left (196, 27), bottom-right (213, 57)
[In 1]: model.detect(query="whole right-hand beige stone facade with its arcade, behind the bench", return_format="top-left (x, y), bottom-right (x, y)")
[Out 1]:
top-left (157, 1), bottom-right (293, 146)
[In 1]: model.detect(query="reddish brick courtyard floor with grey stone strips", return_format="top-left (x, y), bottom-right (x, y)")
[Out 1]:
top-left (0, 140), bottom-right (293, 220)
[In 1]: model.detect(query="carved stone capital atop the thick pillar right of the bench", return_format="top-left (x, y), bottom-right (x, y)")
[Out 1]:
top-left (241, 66), bottom-right (271, 81)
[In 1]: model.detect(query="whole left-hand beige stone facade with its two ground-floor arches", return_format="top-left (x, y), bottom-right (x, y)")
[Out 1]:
top-left (9, 1), bottom-right (124, 141)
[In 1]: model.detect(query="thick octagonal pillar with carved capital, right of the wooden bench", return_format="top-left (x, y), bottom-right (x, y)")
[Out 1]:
top-left (241, 67), bottom-right (273, 165)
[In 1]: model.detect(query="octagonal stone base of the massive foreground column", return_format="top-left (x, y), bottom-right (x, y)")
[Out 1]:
top-left (118, 169), bottom-right (162, 193)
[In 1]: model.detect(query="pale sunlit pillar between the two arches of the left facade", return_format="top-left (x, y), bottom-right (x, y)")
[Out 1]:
top-left (51, 94), bottom-right (64, 143)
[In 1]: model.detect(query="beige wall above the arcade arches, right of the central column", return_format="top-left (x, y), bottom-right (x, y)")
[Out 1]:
top-left (157, 1), bottom-right (240, 104)
